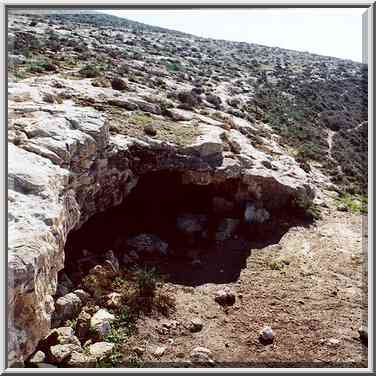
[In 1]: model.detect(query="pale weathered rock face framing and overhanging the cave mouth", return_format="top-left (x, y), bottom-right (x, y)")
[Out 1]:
top-left (8, 75), bottom-right (314, 364)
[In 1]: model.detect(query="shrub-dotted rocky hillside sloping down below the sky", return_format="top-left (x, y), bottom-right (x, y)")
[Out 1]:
top-left (9, 10), bottom-right (368, 192)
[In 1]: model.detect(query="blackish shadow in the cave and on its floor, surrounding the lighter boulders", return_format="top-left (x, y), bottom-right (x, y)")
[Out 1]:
top-left (65, 171), bottom-right (311, 287)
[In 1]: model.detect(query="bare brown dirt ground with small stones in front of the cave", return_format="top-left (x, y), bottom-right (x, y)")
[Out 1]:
top-left (119, 195), bottom-right (367, 367)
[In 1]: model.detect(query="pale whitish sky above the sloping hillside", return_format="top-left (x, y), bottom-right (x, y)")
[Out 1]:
top-left (101, 8), bottom-right (365, 62)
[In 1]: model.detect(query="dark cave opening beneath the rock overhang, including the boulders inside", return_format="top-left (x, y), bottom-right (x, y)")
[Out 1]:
top-left (64, 171), bottom-right (302, 286)
